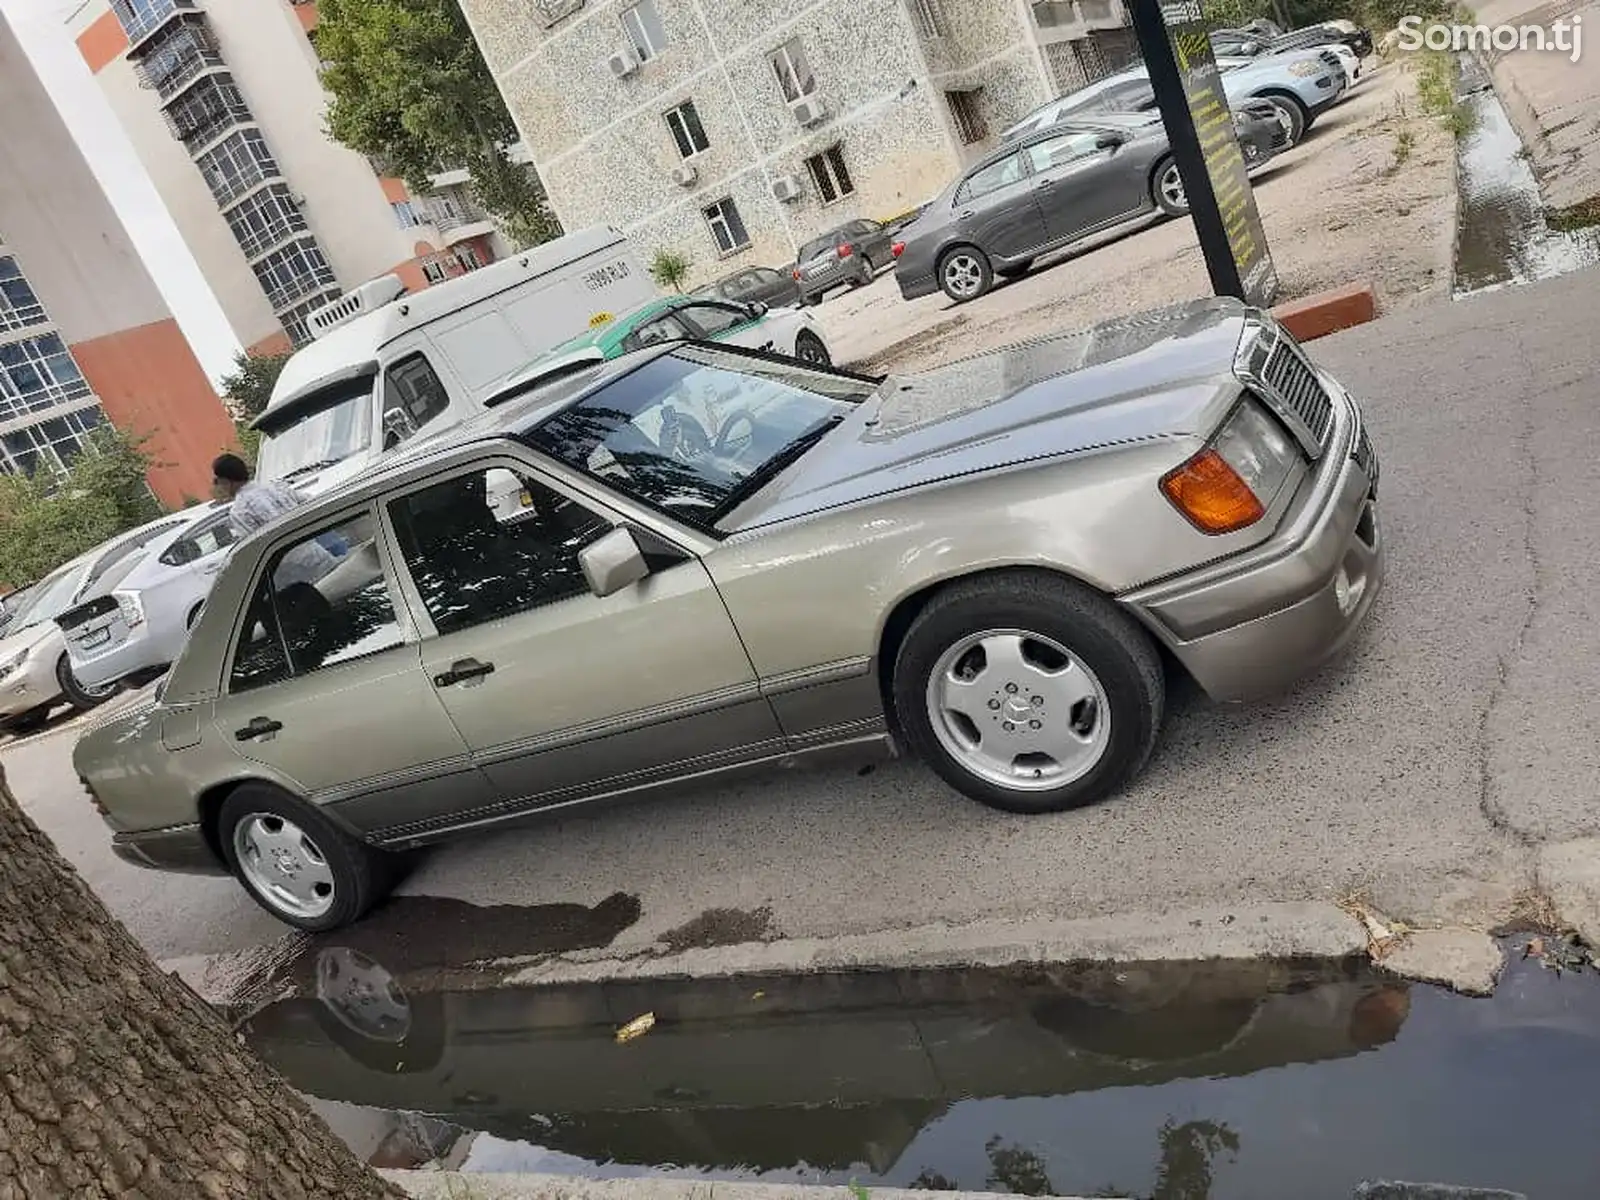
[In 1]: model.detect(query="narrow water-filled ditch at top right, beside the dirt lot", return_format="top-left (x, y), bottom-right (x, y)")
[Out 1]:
top-left (1454, 58), bottom-right (1600, 296)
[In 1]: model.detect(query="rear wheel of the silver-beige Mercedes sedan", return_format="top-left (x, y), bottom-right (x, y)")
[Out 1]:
top-left (218, 782), bottom-right (395, 933)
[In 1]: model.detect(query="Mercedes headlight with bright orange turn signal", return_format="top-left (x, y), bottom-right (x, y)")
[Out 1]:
top-left (1162, 398), bottom-right (1301, 534)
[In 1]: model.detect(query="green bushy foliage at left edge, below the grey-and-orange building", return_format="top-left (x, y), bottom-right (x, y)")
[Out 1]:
top-left (0, 426), bottom-right (162, 587)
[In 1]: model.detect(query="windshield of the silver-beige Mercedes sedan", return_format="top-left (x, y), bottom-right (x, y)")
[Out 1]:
top-left (528, 346), bottom-right (877, 526)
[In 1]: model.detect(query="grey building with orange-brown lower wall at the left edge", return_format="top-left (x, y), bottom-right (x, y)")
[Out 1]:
top-left (0, 14), bottom-right (234, 506)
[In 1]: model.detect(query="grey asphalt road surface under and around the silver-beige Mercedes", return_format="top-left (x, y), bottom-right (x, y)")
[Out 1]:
top-left (3, 270), bottom-right (1600, 985)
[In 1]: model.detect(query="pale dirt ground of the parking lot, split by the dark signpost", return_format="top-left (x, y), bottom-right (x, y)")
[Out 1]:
top-left (814, 59), bottom-right (1456, 371)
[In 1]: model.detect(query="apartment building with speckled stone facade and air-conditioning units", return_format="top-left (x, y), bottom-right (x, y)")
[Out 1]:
top-left (462, 0), bottom-right (1138, 283)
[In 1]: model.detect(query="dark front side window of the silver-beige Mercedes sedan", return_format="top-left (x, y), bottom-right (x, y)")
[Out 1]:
top-left (389, 467), bottom-right (611, 634)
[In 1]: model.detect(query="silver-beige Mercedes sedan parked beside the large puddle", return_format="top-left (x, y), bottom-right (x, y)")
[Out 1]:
top-left (74, 301), bottom-right (1384, 930)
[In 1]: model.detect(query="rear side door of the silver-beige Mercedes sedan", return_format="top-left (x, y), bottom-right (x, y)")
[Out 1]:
top-left (211, 507), bottom-right (491, 832)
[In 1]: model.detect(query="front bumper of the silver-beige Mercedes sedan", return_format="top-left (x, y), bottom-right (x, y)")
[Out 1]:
top-left (1123, 374), bottom-right (1386, 701)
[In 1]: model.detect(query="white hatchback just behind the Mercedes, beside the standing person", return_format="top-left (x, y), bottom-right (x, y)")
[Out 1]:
top-left (56, 504), bottom-right (237, 688)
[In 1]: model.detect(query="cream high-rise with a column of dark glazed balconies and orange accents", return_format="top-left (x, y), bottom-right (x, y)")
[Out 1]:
top-left (69, 0), bottom-right (506, 354)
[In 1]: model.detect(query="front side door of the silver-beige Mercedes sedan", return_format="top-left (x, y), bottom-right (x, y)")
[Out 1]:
top-left (386, 454), bottom-right (782, 811)
